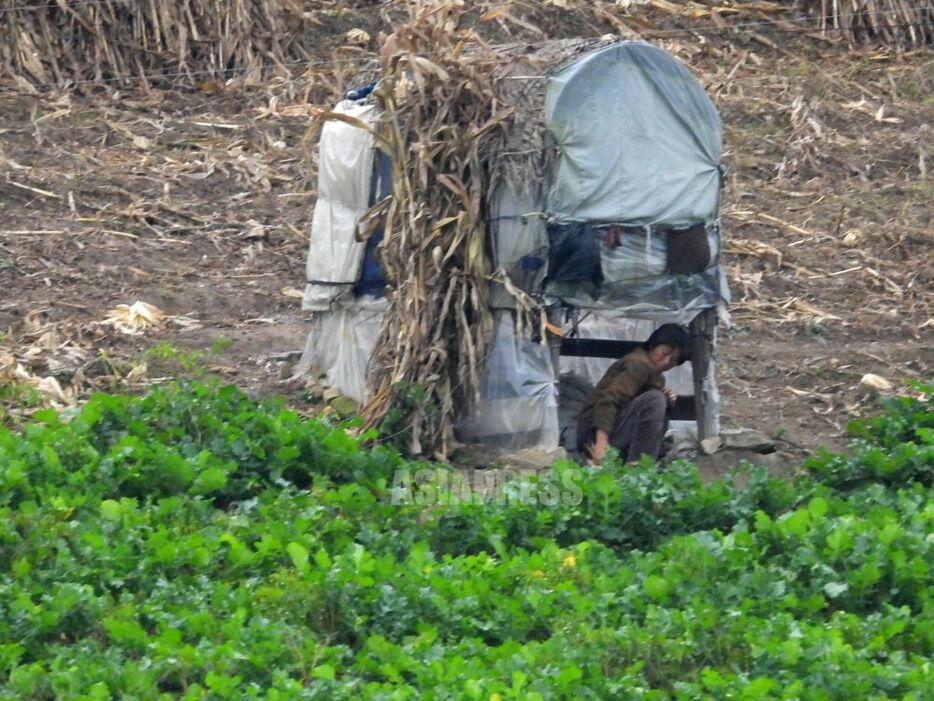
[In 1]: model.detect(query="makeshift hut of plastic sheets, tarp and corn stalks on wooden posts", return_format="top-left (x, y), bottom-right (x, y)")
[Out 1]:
top-left (300, 35), bottom-right (729, 453)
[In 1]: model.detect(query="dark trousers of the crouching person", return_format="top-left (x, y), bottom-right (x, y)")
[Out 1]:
top-left (577, 389), bottom-right (668, 462)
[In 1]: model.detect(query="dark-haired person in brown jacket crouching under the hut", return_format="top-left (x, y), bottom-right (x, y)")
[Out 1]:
top-left (577, 324), bottom-right (689, 464)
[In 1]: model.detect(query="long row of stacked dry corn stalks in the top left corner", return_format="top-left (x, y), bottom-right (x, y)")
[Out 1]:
top-left (0, 0), bottom-right (320, 85)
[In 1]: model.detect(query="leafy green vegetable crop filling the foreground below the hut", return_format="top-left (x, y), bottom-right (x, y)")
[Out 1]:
top-left (0, 383), bottom-right (934, 701)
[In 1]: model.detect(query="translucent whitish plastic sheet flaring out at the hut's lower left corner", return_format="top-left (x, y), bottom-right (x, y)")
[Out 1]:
top-left (295, 297), bottom-right (388, 402)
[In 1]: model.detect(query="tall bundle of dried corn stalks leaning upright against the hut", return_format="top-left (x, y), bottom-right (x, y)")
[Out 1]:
top-left (364, 0), bottom-right (528, 455)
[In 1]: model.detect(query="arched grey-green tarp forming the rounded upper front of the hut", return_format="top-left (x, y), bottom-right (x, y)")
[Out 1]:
top-left (545, 42), bottom-right (722, 226)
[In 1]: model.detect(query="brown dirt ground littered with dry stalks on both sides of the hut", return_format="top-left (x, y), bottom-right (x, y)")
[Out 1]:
top-left (0, 21), bottom-right (934, 462)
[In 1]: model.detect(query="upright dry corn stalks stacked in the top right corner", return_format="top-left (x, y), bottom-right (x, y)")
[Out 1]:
top-left (803, 0), bottom-right (934, 48)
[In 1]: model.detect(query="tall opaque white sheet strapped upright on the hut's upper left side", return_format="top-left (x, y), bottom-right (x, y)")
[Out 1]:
top-left (302, 100), bottom-right (378, 311)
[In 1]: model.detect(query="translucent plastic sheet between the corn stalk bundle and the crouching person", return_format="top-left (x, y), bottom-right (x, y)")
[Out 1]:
top-left (456, 311), bottom-right (558, 450)
